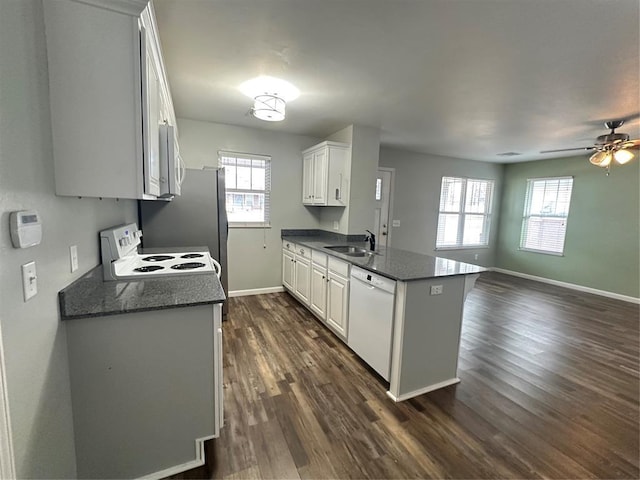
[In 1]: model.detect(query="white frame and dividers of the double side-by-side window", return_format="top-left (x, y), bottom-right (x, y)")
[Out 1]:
top-left (435, 175), bottom-right (496, 251)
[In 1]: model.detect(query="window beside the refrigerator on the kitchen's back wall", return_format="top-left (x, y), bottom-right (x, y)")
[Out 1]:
top-left (218, 152), bottom-right (271, 227)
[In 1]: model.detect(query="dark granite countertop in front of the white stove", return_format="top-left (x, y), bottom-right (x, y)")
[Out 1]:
top-left (58, 256), bottom-right (226, 320)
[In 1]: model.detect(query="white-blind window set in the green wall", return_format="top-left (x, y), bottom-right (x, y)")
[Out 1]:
top-left (520, 177), bottom-right (573, 255)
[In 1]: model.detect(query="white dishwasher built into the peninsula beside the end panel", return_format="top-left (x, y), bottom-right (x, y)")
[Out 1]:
top-left (347, 266), bottom-right (396, 381)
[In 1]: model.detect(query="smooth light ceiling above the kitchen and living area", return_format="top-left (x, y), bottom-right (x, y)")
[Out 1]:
top-left (154, 0), bottom-right (640, 163)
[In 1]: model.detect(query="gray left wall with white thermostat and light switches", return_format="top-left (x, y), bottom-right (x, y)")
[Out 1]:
top-left (0, 0), bottom-right (136, 478)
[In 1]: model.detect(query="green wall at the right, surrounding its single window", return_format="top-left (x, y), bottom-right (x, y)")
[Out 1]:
top-left (496, 156), bottom-right (640, 298)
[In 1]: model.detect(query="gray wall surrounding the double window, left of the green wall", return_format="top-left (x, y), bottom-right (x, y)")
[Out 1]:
top-left (380, 148), bottom-right (503, 266)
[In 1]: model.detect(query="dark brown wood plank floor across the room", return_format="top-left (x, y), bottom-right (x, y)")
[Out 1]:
top-left (168, 273), bottom-right (640, 479)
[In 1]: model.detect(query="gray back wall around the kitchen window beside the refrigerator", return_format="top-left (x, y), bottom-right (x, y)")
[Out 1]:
top-left (178, 118), bottom-right (322, 291)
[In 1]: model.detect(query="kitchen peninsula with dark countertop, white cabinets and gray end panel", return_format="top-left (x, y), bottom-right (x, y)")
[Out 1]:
top-left (282, 230), bottom-right (485, 401)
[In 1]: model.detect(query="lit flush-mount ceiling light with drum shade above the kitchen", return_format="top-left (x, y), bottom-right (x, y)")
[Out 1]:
top-left (238, 75), bottom-right (300, 122)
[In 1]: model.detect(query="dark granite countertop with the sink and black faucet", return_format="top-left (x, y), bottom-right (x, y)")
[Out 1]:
top-left (282, 232), bottom-right (486, 282)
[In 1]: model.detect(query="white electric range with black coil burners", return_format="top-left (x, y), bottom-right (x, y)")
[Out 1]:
top-left (100, 223), bottom-right (221, 280)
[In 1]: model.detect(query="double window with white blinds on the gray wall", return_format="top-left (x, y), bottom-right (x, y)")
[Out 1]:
top-left (436, 177), bottom-right (493, 248)
